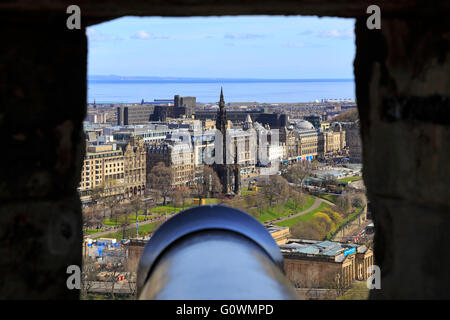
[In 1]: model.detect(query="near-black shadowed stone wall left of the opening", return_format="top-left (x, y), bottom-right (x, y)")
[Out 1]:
top-left (0, 16), bottom-right (87, 299)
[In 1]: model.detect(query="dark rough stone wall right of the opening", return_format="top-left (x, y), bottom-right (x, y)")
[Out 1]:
top-left (354, 18), bottom-right (450, 299)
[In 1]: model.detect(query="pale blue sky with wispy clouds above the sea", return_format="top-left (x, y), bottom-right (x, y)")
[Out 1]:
top-left (87, 16), bottom-right (355, 79)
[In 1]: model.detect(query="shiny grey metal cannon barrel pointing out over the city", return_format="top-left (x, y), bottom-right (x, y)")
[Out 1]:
top-left (137, 205), bottom-right (297, 300)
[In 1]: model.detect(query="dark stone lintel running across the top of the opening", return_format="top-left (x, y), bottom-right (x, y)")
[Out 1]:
top-left (0, 0), bottom-right (450, 24)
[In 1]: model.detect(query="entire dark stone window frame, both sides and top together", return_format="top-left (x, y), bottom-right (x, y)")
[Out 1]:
top-left (0, 0), bottom-right (450, 299)
